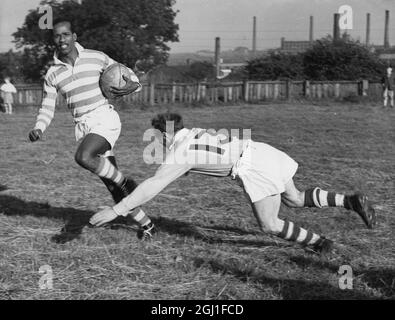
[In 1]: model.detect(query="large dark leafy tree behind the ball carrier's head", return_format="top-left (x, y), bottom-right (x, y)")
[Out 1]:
top-left (13, 0), bottom-right (178, 79)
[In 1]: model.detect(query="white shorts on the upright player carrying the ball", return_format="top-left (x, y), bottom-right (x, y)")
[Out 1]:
top-left (74, 105), bottom-right (121, 149)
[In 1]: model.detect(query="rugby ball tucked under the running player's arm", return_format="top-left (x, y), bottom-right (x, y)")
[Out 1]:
top-left (99, 63), bottom-right (131, 99)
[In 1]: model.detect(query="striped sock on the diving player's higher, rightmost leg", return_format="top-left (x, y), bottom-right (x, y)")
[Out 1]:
top-left (304, 188), bottom-right (344, 208)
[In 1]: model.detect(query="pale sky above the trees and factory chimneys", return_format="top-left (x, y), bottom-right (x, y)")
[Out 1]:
top-left (0, 0), bottom-right (395, 53)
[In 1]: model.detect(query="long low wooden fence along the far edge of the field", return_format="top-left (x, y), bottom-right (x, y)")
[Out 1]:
top-left (15, 80), bottom-right (382, 106)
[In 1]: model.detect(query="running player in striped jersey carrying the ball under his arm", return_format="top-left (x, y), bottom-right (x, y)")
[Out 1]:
top-left (29, 20), bottom-right (151, 235)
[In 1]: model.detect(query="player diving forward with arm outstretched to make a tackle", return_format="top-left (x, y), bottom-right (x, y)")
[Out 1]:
top-left (90, 113), bottom-right (376, 254)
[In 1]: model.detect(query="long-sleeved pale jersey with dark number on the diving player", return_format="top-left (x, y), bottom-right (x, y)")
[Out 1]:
top-left (113, 129), bottom-right (248, 216)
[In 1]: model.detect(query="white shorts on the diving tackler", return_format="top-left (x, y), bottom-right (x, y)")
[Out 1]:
top-left (232, 140), bottom-right (298, 202)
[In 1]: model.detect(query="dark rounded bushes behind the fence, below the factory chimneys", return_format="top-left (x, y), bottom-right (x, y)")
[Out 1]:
top-left (245, 35), bottom-right (385, 80)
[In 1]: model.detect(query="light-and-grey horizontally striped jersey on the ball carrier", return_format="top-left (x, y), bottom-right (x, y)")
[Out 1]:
top-left (34, 42), bottom-right (141, 132)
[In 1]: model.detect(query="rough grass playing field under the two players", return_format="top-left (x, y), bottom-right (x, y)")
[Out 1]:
top-left (0, 104), bottom-right (395, 299)
